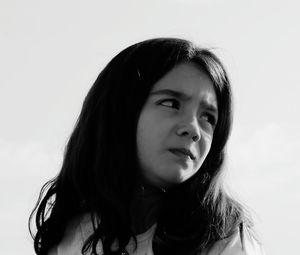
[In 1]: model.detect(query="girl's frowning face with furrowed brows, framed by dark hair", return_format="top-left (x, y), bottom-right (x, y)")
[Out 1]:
top-left (137, 63), bottom-right (218, 187)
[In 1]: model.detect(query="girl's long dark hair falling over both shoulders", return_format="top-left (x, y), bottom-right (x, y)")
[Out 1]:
top-left (29, 38), bottom-right (251, 255)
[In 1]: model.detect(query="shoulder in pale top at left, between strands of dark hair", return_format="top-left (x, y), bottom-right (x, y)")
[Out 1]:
top-left (48, 214), bottom-right (101, 255)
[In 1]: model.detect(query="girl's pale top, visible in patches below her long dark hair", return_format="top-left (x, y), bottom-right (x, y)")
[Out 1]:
top-left (48, 215), bottom-right (265, 255)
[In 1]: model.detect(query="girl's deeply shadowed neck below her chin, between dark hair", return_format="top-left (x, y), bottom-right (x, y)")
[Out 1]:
top-left (130, 183), bottom-right (165, 235)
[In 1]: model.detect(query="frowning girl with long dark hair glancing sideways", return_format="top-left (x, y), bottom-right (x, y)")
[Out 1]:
top-left (30, 38), bottom-right (262, 255)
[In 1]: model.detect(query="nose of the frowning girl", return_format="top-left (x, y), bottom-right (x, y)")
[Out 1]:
top-left (176, 119), bottom-right (201, 142)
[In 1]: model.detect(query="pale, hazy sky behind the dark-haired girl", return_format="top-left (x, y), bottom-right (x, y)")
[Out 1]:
top-left (0, 0), bottom-right (300, 255)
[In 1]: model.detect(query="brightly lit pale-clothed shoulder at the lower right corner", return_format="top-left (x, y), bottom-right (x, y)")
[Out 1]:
top-left (201, 224), bottom-right (265, 255)
